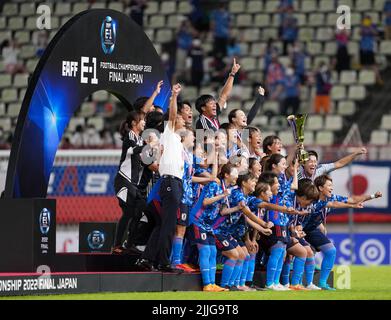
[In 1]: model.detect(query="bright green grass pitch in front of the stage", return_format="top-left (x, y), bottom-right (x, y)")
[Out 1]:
top-left (0, 266), bottom-right (391, 300)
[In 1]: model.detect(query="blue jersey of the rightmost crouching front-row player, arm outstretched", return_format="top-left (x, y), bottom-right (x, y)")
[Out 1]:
top-left (303, 194), bottom-right (348, 231)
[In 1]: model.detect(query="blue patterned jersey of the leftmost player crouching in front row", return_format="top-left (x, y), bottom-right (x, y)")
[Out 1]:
top-left (190, 182), bottom-right (225, 232)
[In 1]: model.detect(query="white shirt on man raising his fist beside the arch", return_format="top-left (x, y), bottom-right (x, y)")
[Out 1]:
top-left (159, 124), bottom-right (185, 180)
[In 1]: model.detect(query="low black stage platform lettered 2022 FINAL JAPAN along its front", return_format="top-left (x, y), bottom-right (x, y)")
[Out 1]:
top-left (0, 253), bottom-right (333, 296)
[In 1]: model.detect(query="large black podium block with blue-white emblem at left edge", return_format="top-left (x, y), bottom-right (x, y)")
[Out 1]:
top-left (0, 198), bottom-right (56, 273)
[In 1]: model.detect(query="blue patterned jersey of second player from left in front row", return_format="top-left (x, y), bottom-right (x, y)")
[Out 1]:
top-left (213, 188), bottom-right (247, 234)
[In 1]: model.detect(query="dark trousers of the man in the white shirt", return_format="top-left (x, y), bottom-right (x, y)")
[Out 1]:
top-left (142, 176), bottom-right (183, 265)
